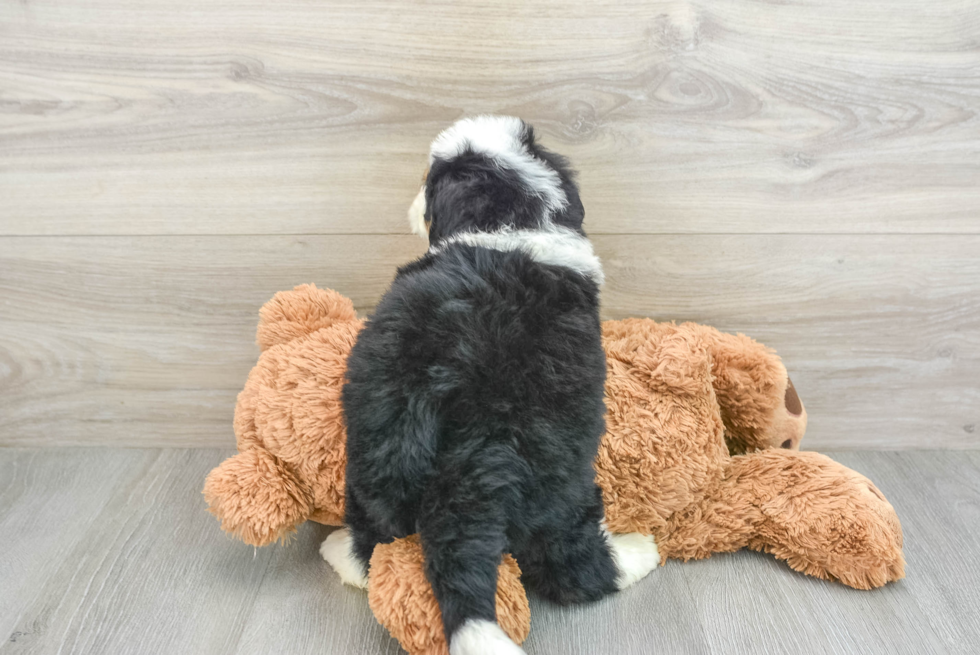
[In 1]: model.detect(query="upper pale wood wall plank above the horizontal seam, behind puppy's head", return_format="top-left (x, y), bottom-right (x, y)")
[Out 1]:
top-left (0, 0), bottom-right (980, 235)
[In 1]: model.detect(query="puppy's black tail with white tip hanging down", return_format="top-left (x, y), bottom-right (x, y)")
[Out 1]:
top-left (420, 447), bottom-right (524, 655)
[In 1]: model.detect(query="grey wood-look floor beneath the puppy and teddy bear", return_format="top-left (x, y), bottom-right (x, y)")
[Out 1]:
top-left (0, 448), bottom-right (980, 655)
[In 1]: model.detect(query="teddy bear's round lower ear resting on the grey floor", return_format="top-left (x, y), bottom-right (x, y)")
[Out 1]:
top-left (204, 448), bottom-right (313, 546)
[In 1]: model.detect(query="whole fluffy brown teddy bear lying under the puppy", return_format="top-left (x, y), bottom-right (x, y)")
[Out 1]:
top-left (204, 285), bottom-right (905, 655)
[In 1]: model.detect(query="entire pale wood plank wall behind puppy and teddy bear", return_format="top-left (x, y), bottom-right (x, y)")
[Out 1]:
top-left (0, 0), bottom-right (980, 448)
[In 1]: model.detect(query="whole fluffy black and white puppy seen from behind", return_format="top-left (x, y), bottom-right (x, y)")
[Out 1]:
top-left (321, 116), bottom-right (659, 655)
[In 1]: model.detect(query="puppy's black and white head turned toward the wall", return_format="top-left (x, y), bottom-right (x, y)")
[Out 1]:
top-left (408, 116), bottom-right (585, 245)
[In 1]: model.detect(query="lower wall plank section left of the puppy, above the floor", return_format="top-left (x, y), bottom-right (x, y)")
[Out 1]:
top-left (0, 236), bottom-right (424, 446)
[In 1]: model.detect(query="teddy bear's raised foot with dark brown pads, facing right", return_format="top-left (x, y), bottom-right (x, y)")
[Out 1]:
top-left (701, 326), bottom-right (807, 455)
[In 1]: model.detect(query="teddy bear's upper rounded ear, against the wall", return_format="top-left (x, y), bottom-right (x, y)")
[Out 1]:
top-left (255, 284), bottom-right (357, 351)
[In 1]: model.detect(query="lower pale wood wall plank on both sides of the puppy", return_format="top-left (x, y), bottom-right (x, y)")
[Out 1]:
top-left (0, 235), bottom-right (980, 448)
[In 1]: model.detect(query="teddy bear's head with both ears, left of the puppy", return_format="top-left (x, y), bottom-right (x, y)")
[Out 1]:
top-left (204, 285), bottom-right (363, 546)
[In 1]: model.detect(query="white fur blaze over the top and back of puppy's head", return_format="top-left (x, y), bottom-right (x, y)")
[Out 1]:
top-left (429, 116), bottom-right (568, 214)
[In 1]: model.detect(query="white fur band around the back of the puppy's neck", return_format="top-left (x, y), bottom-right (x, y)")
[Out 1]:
top-left (429, 225), bottom-right (605, 284)
